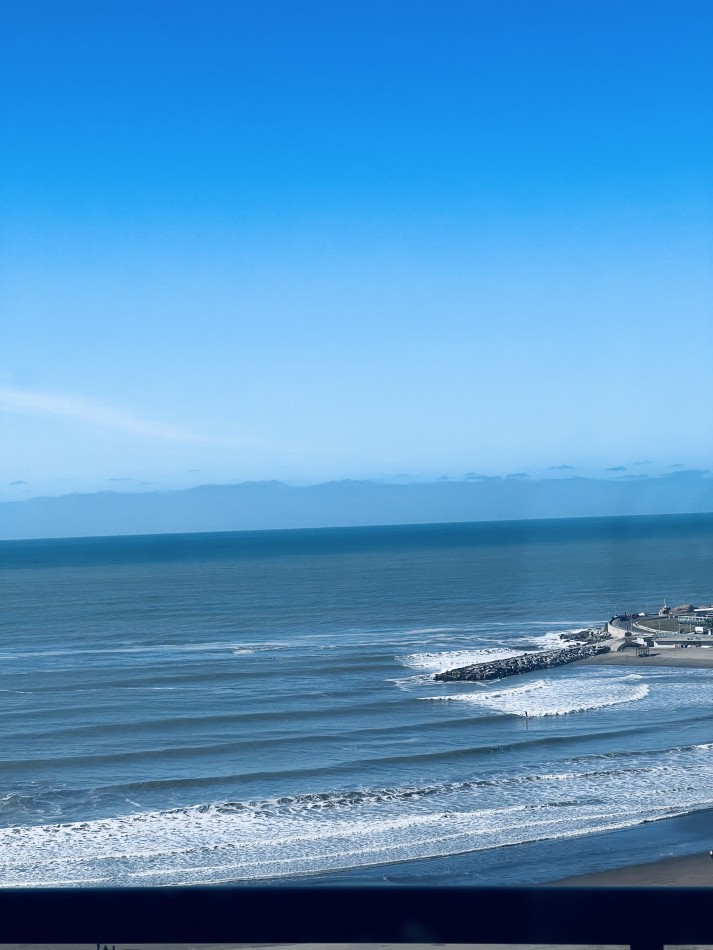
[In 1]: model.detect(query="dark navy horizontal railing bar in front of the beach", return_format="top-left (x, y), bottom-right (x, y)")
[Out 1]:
top-left (0, 886), bottom-right (713, 950)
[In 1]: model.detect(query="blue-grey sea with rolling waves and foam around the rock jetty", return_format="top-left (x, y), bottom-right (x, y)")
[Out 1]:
top-left (0, 515), bottom-right (713, 886)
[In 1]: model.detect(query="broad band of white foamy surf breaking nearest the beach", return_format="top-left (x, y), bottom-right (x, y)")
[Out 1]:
top-left (0, 744), bottom-right (713, 887)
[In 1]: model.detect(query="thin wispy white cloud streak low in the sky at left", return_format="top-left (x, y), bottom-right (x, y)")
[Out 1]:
top-left (0, 387), bottom-right (232, 445)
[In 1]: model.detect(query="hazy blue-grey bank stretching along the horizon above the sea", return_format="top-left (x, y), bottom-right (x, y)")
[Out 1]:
top-left (0, 469), bottom-right (713, 540)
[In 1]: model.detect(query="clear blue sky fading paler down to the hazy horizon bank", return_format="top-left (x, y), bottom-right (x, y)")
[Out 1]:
top-left (0, 0), bottom-right (713, 498)
